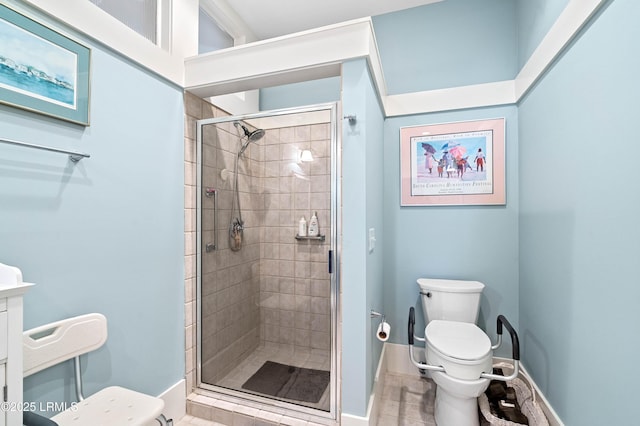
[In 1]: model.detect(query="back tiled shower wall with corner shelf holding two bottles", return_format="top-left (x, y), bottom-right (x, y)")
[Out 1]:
top-left (260, 123), bottom-right (331, 352)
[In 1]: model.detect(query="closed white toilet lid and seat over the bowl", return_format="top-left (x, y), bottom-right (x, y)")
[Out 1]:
top-left (425, 320), bottom-right (493, 380)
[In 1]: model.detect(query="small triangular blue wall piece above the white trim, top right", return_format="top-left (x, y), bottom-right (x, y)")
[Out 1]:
top-left (516, 0), bottom-right (569, 69)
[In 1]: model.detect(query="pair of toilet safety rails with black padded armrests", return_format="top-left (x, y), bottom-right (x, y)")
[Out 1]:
top-left (407, 306), bottom-right (520, 381)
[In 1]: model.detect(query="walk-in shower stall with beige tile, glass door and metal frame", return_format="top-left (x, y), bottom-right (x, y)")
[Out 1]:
top-left (196, 104), bottom-right (340, 419)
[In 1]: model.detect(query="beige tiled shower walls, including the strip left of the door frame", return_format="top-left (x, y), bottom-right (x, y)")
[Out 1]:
top-left (185, 93), bottom-right (331, 393)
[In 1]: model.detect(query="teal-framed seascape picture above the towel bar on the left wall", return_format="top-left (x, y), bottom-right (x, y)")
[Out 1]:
top-left (0, 5), bottom-right (91, 126)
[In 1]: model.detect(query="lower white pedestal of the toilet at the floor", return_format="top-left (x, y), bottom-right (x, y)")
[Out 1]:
top-left (435, 386), bottom-right (480, 426)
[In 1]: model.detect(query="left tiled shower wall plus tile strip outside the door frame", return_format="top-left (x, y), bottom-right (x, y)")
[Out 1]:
top-left (185, 93), bottom-right (264, 389)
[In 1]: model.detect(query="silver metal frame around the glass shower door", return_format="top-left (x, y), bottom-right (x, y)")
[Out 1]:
top-left (195, 102), bottom-right (342, 421)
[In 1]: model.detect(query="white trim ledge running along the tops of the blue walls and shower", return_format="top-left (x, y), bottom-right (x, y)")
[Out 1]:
top-left (11, 0), bottom-right (606, 117)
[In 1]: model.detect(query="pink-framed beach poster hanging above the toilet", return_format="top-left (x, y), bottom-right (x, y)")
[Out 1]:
top-left (400, 118), bottom-right (506, 206)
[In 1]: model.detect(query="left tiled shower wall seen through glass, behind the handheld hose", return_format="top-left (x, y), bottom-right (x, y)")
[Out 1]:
top-left (201, 119), bottom-right (264, 384)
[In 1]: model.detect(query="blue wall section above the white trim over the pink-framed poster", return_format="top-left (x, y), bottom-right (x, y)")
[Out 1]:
top-left (373, 0), bottom-right (518, 95)
